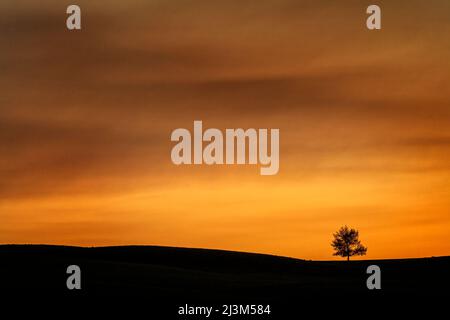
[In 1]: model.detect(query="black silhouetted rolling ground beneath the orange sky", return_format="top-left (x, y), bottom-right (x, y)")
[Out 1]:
top-left (0, 245), bottom-right (450, 319)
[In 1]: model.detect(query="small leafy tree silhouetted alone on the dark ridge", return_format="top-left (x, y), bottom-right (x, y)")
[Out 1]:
top-left (331, 226), bottom-right (367, 261)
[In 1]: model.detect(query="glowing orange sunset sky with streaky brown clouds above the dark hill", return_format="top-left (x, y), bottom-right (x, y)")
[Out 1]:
top-left (0, 0), bottom-right (450, 260)
